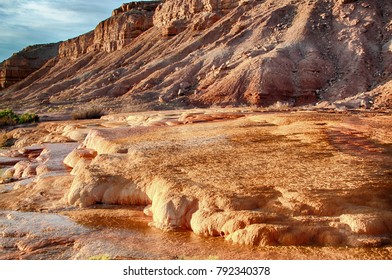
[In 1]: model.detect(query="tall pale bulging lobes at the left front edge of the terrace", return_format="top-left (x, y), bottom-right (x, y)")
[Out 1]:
top-left (68, 149), bottom-right (198, 229)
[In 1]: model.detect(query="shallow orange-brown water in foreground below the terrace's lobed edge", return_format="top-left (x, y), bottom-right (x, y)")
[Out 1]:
top-left (0, 208), bottom-right (392, 260)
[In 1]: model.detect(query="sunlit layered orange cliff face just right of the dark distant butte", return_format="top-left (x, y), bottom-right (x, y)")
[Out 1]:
top-left (59, 1), bottom-right (160, 59)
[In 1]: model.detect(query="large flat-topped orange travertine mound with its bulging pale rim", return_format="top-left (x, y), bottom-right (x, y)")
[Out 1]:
top-left (62, 112), bottom-right (392, 246)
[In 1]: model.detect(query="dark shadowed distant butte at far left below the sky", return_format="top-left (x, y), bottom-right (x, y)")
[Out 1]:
top-left (0, 43), bottom-right (59, 89)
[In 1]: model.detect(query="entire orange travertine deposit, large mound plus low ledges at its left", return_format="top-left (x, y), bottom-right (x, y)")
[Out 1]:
top-left (0, 109), bottom-right (392, 252)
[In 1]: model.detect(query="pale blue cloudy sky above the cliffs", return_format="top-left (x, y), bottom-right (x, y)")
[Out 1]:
top-left (0, 0), bottom-right (127, 62)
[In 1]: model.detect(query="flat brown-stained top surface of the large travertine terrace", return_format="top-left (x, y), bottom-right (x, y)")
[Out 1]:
top-left (108, 110), bottom-right (392, 216)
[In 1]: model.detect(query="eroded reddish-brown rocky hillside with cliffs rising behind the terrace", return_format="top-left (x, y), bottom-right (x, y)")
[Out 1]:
top-left (2, 0), bottom-right (392, 110)
